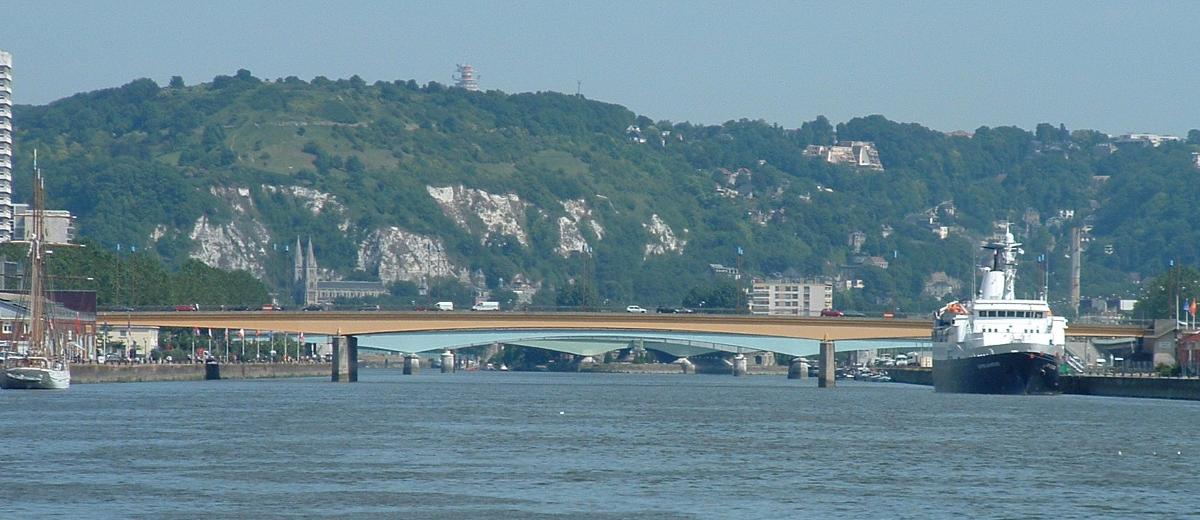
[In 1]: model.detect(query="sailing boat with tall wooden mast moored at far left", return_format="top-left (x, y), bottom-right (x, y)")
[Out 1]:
top-left (0, 151), bottom-right (71, 389)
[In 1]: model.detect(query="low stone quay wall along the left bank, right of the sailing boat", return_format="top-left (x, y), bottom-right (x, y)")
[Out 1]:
top-left (71, 363), bottom-right (332, 384)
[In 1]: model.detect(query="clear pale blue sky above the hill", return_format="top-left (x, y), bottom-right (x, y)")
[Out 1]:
top-left (0, 0), bottom-right (1200, 135)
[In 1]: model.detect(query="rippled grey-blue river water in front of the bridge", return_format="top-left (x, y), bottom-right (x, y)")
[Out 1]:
top-left (0, 370), bottom-right (1200, 519)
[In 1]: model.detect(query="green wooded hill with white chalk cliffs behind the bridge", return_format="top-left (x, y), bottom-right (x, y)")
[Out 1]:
top-left (14, 71), bottom-right (1200, 312)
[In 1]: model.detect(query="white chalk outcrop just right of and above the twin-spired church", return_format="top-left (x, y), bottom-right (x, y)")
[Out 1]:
top-left (356, 227), bottom-right (461, 283)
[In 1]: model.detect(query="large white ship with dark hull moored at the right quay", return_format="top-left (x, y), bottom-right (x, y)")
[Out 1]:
top-left (932, 226), bottom-right (1067, 394)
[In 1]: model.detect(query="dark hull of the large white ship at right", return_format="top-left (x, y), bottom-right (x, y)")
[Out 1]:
top-left (934, 352), bottom-right (1060, 395)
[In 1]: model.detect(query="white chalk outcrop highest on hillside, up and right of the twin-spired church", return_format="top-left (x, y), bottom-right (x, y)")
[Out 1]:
top-left (426, 185), bottom-right (529, 246)
